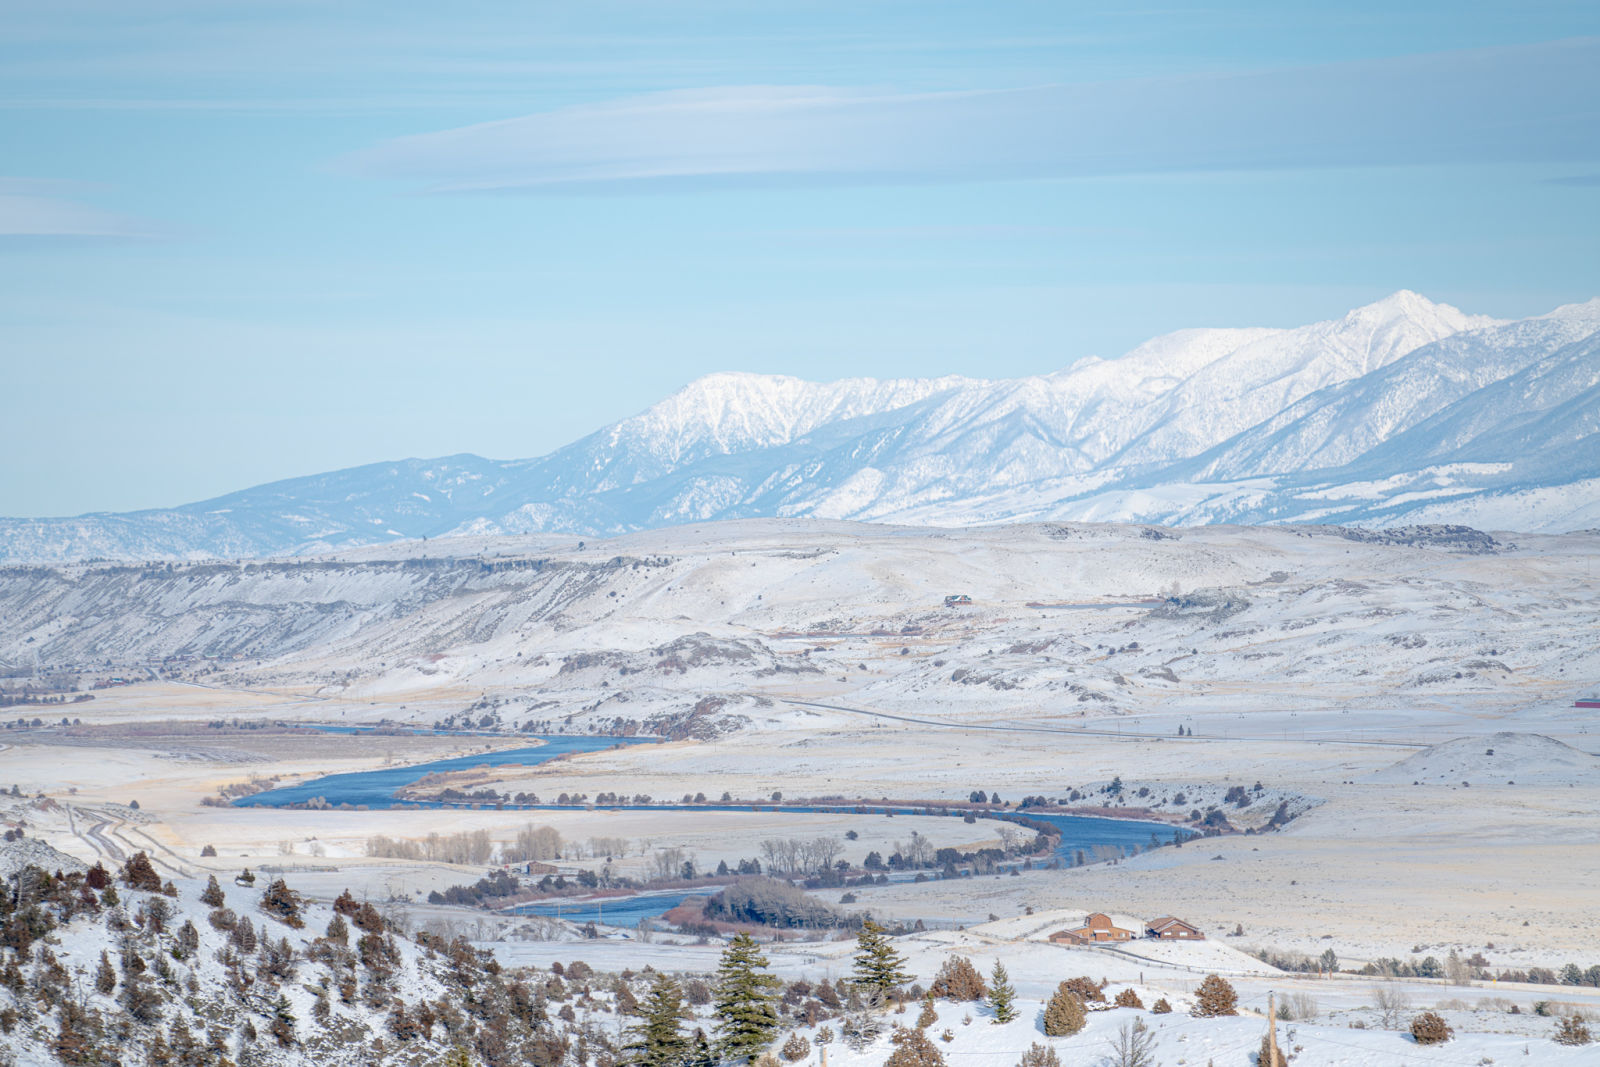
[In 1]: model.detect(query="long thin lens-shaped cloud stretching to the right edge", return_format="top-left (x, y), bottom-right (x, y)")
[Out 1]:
top-left (341, 38), bottom-right (1600, 192)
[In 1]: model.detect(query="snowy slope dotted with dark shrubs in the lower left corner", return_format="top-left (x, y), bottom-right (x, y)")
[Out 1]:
top-left (0, 854), bottom-right (604, 1067)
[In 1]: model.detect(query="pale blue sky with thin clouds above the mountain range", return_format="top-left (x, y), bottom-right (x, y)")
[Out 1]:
top-left (0, 0), bottom-right (1600, 515)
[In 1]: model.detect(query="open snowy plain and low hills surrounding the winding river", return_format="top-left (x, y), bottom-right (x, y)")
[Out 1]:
top-left (0, 520), bottom-right (1600, 1067)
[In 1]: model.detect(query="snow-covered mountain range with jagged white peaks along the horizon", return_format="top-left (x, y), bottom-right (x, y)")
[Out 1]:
top-left (0, 291), bottom-right (1600, 561)
